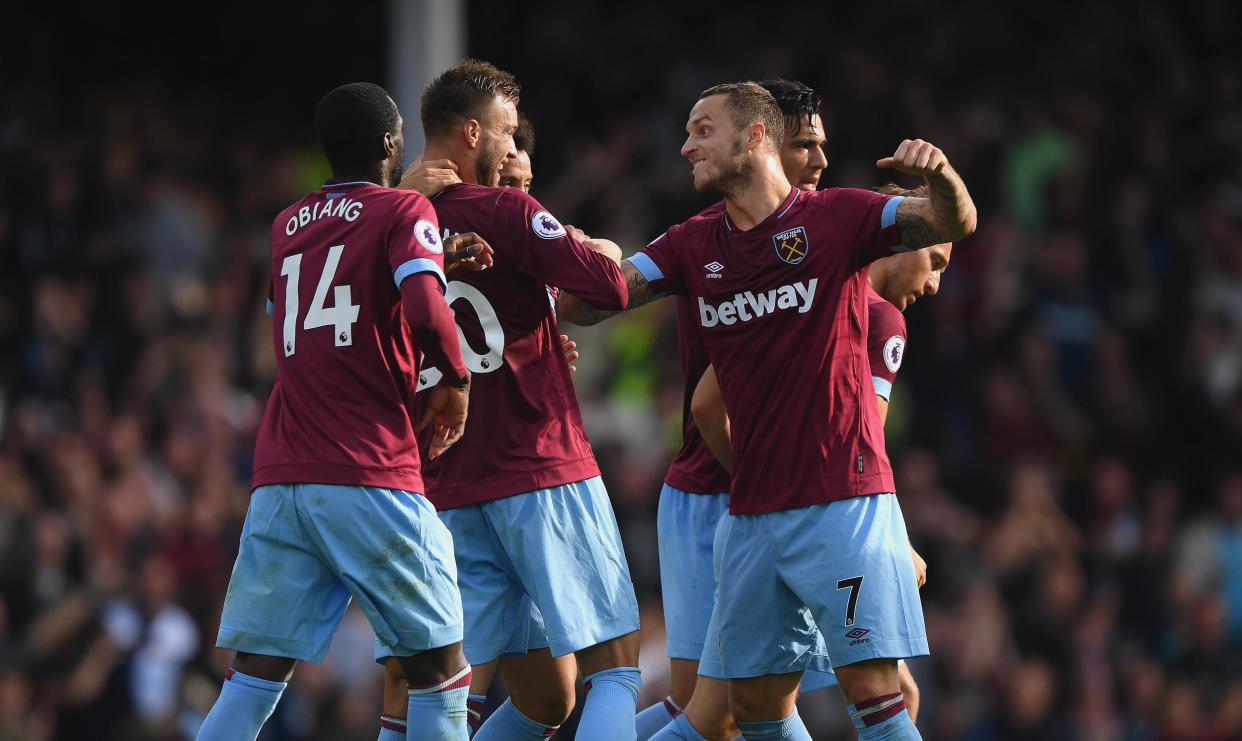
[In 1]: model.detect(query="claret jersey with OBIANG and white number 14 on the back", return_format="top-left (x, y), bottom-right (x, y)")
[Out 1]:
top-left (251, 182), bottom-right (443, 493)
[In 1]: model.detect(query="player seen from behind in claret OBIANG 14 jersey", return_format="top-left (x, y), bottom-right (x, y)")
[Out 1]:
top-left (199, 83), bottom-right (479, 741)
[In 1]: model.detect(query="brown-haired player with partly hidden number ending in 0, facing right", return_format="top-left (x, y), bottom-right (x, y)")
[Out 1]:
top-left (380, 61), bottom-right (638, 739)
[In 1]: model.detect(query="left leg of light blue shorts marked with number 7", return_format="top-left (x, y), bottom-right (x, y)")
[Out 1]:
top-left (699, 515), bottom-right (818, 679)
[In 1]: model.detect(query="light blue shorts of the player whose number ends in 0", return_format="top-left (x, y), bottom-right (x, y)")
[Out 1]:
top-left (378, 477), bottom-right (638, 665)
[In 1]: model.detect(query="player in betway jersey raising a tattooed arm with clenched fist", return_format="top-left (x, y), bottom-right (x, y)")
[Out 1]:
top-left (622, 83), bottom-right (975, 739)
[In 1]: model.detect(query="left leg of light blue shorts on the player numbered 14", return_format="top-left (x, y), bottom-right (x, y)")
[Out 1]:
top-left (216, 485), bottom-right (349, 662)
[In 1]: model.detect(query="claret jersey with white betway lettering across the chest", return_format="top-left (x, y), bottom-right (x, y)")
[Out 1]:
top-left (630, 189), bottom-right (902, 515)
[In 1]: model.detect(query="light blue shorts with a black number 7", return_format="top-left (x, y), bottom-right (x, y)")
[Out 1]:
top-left (700, 494), bottom-right (928, 689)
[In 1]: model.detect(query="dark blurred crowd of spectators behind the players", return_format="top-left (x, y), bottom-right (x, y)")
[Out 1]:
top-left (0, 0), bottom-right (1242, 741)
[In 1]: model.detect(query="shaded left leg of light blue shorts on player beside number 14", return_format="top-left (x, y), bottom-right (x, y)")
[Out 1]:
top-left (440, 505), bottom-right (529, 665)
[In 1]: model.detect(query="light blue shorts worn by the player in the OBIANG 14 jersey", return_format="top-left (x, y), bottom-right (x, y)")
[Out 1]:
top-left (216, 484), bottom-right (462, 662)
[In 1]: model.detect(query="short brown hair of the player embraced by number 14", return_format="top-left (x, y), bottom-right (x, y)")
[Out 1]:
top-left (420, 58), bottom-right (522, 139)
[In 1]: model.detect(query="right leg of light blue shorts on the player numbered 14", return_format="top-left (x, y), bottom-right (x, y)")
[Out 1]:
top-left (298, 484), bottom-right (462, 660)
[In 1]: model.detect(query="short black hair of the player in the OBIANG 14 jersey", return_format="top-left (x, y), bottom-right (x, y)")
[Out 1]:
top-left (314, 82), bottom-right (401, 174)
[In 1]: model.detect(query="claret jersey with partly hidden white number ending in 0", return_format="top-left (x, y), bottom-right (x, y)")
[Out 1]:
top-left (420, 184), bottom-right (628, 510)
